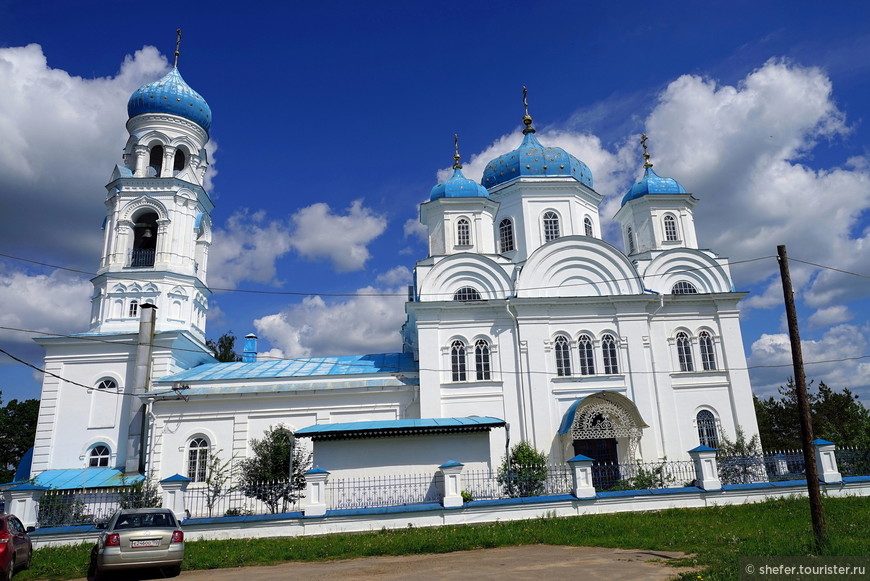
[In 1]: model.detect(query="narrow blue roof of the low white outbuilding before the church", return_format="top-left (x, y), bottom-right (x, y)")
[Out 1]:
top-left (296, 417), bottom-right (505, 440)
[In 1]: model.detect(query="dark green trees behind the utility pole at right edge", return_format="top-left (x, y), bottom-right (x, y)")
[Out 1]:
top-left (755, 378), bottom-right (870, 450)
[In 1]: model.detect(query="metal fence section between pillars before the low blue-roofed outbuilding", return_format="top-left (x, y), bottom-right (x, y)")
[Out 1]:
top-left (326, 472), bottom-right (444, 509)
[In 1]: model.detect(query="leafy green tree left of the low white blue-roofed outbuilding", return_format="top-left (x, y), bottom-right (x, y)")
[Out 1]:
top-left (236, 424), bottom-right (311, 514)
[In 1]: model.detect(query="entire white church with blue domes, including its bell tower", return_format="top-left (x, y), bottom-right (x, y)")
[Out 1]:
top-left (24, 57), bottom-right (758, 487)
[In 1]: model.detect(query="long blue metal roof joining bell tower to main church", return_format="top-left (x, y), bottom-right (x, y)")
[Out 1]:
top-left (157, 353), bottom-right (419, 381)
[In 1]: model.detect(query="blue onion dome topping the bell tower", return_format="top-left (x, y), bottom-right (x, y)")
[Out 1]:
top-left (127, 67), bottom-right (211, 131)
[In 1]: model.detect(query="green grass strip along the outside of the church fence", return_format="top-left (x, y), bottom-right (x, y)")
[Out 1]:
top-left (15, 498), bottom-right (870, 581)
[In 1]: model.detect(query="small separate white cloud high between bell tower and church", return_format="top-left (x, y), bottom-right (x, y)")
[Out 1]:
top-left (290, 200), bottom-right (387, 272)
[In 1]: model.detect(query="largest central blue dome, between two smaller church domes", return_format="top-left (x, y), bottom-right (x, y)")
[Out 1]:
top-left (482, 132), bottom-right (592, 188)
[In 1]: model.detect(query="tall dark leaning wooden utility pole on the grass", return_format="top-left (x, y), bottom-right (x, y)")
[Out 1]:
top-left (776, 244), bottom-right (828, 552)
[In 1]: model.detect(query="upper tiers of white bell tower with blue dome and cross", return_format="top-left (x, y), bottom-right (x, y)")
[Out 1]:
top-left (90, 32), bottom-right (214, 341)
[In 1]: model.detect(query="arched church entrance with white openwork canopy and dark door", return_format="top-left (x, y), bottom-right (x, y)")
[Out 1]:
top-left (559, 391), bottom-right (649, 490)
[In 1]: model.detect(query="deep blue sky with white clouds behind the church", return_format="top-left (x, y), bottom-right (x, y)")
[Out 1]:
top-left (0, 0), bottom-right (870, 405)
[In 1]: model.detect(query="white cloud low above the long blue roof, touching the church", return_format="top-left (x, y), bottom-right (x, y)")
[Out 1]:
top-left (254, 280), bottom-right (410, 357)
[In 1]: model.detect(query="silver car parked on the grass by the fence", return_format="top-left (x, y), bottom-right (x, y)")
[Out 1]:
top-left (88, 508), bottom-right (184, 579)
